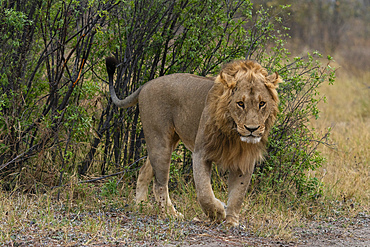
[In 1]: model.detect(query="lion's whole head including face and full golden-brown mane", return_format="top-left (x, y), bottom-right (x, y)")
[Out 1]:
top-left (205, 61), bottom-right (281, 172)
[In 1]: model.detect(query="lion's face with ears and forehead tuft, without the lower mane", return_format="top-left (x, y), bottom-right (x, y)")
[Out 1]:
top-left (211, 62), bottom-right (280, 143)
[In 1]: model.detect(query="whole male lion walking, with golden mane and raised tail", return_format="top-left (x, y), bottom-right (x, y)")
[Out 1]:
top-left (106, 57), bottom-right (280, 226)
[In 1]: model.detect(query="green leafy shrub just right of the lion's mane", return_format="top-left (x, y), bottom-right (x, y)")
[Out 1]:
top-left (254, 52), bottom-right (335, 199)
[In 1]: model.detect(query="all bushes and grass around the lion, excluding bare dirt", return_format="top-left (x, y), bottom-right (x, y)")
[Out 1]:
top-left (0, 0), bottom-right (370, 243)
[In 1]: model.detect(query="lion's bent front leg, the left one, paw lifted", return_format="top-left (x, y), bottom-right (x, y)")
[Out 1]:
top-left (193, 154), bottom-right (226, 222)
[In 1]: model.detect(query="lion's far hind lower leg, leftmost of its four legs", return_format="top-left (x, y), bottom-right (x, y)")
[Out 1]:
top-left (135, 158), bottom-right (154, 204)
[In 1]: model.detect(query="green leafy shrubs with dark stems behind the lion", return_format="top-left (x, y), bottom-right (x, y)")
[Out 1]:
top-left (0, 0), bottom-right (334, 196)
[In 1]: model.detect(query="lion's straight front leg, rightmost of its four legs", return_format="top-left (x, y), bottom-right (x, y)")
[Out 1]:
top-left (226, 167), bottom-right (253, 226)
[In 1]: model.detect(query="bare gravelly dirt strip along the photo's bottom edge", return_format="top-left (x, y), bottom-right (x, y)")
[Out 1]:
top-left (3, 212), bottom-right (370, 247)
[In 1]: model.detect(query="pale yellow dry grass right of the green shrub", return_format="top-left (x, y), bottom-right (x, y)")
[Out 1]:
top-left (313, 72), bottom-right (370, 208)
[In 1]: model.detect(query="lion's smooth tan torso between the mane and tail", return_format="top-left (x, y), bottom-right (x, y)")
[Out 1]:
top-left (139, 74), bottom-right (214, 150)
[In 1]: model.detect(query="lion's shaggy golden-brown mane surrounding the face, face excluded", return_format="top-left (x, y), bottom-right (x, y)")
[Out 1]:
top-left (204, 61), bottom-right (280, 173)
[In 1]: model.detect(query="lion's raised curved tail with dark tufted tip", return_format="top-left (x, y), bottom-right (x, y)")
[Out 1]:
top-left (105, 57), bottom-right (142, 108)
